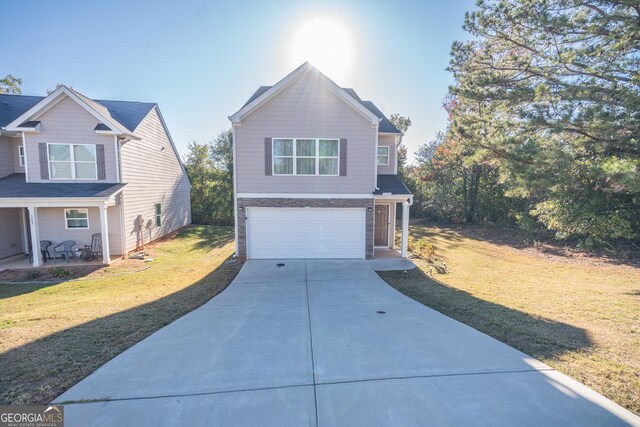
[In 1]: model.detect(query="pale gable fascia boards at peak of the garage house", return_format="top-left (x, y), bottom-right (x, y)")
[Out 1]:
top-left (229, 62), bottom-right (381, 125)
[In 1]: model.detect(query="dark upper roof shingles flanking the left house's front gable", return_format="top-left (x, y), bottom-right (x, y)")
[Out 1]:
top-left (0, 92), bottom-right (156, 132)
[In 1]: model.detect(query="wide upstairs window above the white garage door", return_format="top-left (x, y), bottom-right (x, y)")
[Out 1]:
top-left (273, 138), bottom-right (340, 176)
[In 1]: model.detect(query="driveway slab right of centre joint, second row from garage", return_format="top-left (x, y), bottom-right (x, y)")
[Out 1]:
top-left (307, 279), bottom-right (413, 306)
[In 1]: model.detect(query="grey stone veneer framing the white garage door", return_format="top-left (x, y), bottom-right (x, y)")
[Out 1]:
top-left (236, 198), bottom-right (374, 261)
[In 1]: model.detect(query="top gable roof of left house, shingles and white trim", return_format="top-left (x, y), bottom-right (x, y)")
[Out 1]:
top-left (0, 86), bottom-right (157, 132)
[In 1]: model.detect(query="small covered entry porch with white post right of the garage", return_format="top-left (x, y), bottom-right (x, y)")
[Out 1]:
top-left (373, 175), bottom-right (413, 259)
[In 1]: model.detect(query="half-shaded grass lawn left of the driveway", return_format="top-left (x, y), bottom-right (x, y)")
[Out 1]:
top-left (0, 226), bottom-right (238, 405)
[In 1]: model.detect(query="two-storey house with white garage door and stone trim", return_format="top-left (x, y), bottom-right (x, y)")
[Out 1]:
top-left (229, 63), bottom-right (413, 259)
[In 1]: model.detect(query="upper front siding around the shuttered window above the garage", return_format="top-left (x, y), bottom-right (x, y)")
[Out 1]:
top-left (235, 74), bottom-right (377, 194)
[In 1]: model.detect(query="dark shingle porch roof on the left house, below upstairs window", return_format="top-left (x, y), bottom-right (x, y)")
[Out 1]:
top-left (0, 173), bottom-right (127, 199)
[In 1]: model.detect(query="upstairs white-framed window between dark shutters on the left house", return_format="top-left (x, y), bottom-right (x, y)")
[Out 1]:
top-left (48, 144), bottom-right (98, 180)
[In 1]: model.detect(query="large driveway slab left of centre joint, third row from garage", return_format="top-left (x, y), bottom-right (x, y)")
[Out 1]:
top-left (56, 308), bottom-right (313, 402)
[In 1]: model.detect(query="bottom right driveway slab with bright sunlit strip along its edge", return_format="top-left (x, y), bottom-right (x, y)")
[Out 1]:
top-left (316, 371), bottom-right (638, 427)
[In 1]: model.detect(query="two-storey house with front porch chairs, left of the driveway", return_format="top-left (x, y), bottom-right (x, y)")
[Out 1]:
top-left (0, 86), bottom-right (191, 266)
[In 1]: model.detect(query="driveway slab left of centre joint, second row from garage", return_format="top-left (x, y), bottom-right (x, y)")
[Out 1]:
top-left (201, 282), bottom-right (307, 310)
